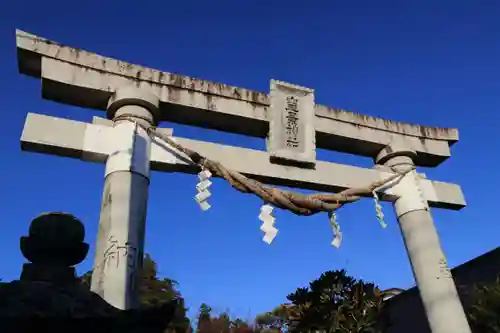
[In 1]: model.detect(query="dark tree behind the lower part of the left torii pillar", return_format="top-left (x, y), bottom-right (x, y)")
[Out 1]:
top-left (80, 254), bottom-right (192, 333)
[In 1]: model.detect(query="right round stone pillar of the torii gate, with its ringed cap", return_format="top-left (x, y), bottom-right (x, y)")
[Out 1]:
top-left (375, 144), bottom-right (471, 333)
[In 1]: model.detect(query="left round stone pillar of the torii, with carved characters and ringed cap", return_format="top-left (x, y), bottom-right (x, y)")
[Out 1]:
top-left (89, 87), bottom-right (160, 310)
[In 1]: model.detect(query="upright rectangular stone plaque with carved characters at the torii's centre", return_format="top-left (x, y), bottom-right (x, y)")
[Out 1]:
top-left (267, 80), bottom-right (316, 165)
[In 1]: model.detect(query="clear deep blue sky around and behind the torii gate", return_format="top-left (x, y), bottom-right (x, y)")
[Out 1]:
top-left (0, 0), bottom-right (500, 317)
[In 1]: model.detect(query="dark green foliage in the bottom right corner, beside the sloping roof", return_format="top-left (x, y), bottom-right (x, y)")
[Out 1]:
top-left (468, 278), bottom-right (500, 333)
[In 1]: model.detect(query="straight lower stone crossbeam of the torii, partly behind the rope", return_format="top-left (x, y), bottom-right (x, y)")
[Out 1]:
top-left (21, 113), bottom-right (466, 210)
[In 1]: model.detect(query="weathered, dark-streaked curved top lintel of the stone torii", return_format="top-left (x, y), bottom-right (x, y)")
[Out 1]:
top-left (16, 30), bottom-right (458, 167)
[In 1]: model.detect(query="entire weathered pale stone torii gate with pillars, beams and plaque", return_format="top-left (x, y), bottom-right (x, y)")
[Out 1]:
top-left (16, 31), bottom-right (470, 333)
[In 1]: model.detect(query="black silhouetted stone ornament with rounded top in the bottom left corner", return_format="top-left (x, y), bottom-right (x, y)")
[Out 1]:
top-left (0, 213), bottom-right (177, 333)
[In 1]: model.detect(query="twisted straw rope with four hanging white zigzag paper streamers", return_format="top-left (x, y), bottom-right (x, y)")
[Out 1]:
top-left (136, 120), bottom-right (415, 248)
